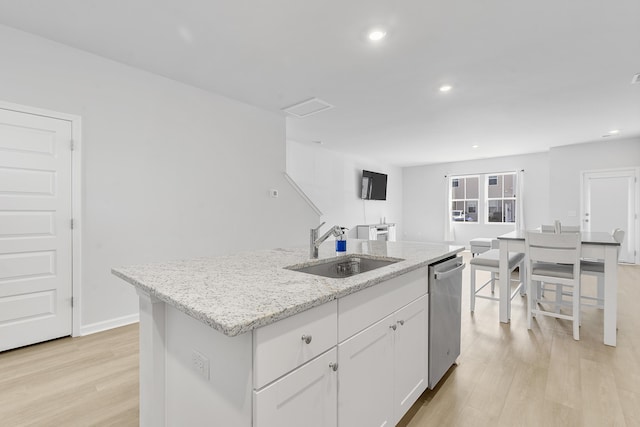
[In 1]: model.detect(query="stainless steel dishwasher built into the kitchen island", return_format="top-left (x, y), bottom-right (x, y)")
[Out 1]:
top-left (429, 257), bottom-right (465, 389)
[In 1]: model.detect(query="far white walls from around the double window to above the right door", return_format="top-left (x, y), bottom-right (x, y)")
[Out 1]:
top-left (403, 137), bottom-right (640, 246)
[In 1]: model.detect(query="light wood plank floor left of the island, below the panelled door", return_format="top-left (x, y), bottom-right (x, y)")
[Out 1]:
top-left (0, 324), bottom-right (138, 427)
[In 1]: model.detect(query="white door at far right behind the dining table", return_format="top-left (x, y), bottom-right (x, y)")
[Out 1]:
top-left (582, 169), bottom-right (638, 263)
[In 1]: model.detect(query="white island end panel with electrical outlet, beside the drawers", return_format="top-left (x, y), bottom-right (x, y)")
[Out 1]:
top-left (165, 306), bottom-right (253, 427)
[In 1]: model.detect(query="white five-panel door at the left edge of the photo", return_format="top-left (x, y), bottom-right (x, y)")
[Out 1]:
top-left (0, 108), bottom-right (72, 351)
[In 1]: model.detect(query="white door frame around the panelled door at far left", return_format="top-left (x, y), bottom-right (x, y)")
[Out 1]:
top-left (0, 100), bottom-right (82, 337)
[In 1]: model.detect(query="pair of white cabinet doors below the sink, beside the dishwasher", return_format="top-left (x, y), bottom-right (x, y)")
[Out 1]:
top-left (338, 295), bottom-right (429, 427)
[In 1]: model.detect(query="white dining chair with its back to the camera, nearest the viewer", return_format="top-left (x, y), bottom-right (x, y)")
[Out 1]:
top-left (525, 231), bottom-right (581, 340)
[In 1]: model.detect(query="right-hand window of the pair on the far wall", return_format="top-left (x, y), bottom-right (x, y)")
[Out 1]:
top-left (486, 173), bottom-right (516, 223)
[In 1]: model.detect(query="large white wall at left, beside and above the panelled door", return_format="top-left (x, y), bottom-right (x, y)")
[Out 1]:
top-left (0, 26), bottom-right (317, 330)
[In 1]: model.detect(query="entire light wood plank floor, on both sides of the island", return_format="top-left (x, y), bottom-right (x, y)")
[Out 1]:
top-left (0, 253), bottom-right (640, 427)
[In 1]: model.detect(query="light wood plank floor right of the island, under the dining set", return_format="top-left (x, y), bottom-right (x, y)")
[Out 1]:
top-left (398, 253), bottom-right (640, 427)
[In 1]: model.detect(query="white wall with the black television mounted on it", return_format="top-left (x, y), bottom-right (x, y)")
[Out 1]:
top-left (287, 141), bottom-right (403, 241)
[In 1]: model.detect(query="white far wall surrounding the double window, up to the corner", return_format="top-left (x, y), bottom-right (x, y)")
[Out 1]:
top-left (402, 153), bottom-right (549, 247)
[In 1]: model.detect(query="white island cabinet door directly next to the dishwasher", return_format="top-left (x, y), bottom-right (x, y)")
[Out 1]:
top-left (393, 295), bottom-right (429, 424)
